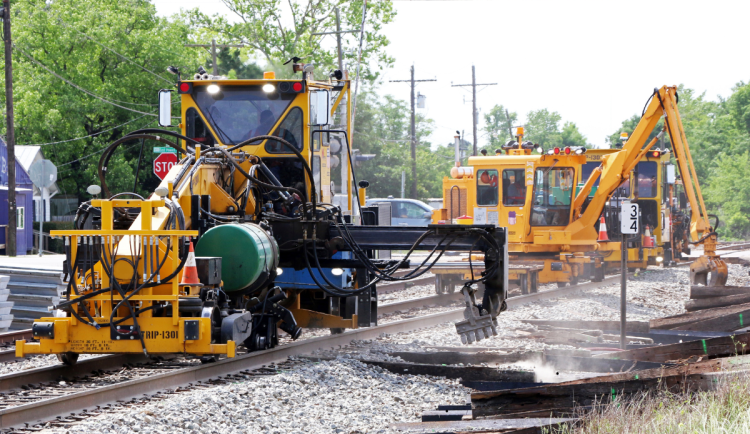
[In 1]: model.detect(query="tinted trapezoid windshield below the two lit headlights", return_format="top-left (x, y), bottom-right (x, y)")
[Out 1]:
top-left (194, 86), bottom-right (296, 144)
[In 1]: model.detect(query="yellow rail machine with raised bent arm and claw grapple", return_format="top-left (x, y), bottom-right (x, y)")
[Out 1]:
top-left (433, 86), bottom-right (727, 286)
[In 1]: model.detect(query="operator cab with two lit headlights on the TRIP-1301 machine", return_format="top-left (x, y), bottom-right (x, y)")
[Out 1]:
top-left (159, 73), bottom-right (338, 213)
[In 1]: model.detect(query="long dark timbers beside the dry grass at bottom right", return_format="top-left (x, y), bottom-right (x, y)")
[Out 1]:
top-left (471, 333), bottom-right (750, 419)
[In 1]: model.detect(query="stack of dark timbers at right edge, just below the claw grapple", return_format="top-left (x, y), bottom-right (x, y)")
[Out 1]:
top-left (649, 286), bottom-right (750, 332)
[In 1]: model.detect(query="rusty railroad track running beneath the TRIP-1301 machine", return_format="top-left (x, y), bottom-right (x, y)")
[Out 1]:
top-left (0, 276), bottom-right (619, 429)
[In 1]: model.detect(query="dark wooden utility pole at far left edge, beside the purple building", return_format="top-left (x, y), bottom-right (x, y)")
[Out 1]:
top-left (2, 0), bottom-right (17, 256)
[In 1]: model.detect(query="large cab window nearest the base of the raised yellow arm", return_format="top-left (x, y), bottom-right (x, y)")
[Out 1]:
top-left (531, 167), bottom-right (574, 226)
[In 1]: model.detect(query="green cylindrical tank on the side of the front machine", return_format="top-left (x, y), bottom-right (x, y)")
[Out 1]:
top-left (195, 223), bottom-right (279, 292)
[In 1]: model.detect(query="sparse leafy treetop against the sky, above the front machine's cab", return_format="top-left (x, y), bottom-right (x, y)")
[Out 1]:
top-left (183, 0), bottom-right (396, 80)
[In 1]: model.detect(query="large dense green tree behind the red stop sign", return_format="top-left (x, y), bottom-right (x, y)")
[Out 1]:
top-left (2, 0), bottom-right (203, 199)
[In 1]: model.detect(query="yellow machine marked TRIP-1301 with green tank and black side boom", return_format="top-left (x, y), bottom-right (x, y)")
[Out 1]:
top-left (16, 64), bottom-right (508, 363)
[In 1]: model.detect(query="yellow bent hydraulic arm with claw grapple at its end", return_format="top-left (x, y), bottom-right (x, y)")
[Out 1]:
top-left (566, 86), bottom-right (727, 286)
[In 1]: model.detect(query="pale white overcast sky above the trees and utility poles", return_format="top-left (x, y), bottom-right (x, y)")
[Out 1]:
top-left (154, 0), bottom-right (750, 146)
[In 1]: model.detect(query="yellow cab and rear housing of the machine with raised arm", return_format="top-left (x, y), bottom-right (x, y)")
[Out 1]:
top-left (433, 136), bottom-right (585, 243)
